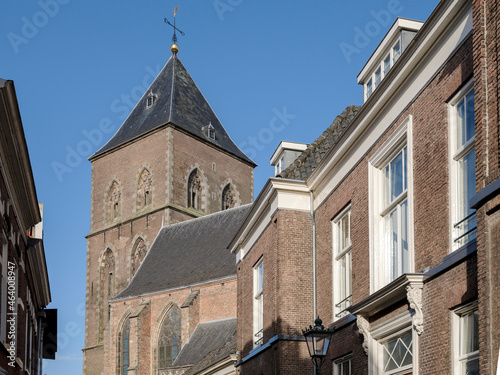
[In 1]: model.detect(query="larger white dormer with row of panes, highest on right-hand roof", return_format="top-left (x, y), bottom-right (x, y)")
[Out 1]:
top-left (358, 18), bottom-right (424, 103)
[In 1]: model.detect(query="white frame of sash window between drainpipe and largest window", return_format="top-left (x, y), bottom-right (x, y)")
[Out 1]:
top-left (332, 204), bottom-right (352, 321)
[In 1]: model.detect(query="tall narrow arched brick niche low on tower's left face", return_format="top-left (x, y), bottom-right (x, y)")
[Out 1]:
top-left (99, 248), bottom-right (115, 341)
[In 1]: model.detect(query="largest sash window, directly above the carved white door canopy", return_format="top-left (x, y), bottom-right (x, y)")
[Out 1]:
top-left (369, 115), bottom-right (414, 292)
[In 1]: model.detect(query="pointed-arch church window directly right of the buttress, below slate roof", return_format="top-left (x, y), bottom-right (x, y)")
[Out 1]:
top-left (158, 306), bottom-right (181, 369)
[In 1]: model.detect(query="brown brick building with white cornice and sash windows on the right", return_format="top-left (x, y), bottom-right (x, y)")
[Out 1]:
top-left (230, 0), bottom-right (500, 374)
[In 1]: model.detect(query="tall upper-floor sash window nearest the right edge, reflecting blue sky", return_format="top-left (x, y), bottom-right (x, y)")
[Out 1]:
top-left (450, 89), bottom-right (476, 249)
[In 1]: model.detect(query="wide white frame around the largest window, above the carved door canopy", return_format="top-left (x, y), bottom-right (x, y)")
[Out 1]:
top-left (368, 115), bottom-right (415, 293)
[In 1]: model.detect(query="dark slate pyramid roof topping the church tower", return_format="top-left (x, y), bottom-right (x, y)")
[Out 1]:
top-left (89, 54), bottom-right (256, 167)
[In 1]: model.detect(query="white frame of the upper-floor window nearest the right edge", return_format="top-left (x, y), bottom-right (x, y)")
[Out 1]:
top-left (448, 79), bottom-right (475, 252)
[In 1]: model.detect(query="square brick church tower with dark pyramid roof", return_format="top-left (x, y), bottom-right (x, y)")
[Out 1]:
top-left (83, 44), bottom-right (256, 375)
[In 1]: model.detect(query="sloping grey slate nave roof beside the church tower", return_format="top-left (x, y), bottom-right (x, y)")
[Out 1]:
top-left (116, 203), bottom-right (252, 299)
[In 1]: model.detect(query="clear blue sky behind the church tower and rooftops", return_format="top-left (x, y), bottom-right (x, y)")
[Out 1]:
top-left (0, 0), bottom-right (438, 375)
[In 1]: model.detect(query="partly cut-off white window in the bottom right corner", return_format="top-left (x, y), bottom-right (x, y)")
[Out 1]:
top-left (452, 303), bottom-right (479, 375)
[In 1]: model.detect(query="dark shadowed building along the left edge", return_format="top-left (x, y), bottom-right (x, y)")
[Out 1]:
top-left (0, 79), bottom-right (57, 375)
